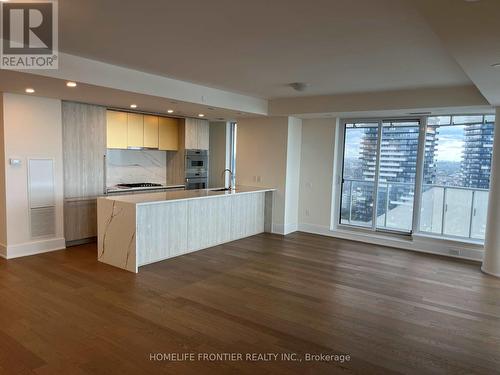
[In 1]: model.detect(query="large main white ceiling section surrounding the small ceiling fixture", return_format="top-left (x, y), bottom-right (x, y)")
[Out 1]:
top-left (59, 0), bottom-right (471, 98)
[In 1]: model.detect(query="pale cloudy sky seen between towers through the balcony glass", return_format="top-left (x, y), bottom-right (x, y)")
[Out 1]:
top-left (345, 126), bottom-right (464, 162)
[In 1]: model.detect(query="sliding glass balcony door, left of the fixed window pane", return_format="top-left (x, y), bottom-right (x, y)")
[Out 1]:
top-left (340, 120), bottom-right (420, 233)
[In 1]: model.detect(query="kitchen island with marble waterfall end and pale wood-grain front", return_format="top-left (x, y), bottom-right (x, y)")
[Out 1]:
top-left (97, 186), bottom-right (274, 273)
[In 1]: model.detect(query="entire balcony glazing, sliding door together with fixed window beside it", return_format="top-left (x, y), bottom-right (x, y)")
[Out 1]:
top-left (339, 115), bottom-right (495, 241)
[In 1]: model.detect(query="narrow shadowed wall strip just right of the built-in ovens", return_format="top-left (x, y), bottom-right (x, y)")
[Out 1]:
top-left (208, 122), bottom-right (227, 188)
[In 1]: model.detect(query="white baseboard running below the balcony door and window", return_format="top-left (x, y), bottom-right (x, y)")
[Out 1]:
top-left (299, 223), bottom-right (483, 262)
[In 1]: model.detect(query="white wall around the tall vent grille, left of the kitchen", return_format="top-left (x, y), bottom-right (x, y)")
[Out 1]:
top-left (3, 94), bottom-right (65, 258)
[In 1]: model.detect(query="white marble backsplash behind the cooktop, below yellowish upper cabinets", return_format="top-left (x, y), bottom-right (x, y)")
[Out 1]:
top-left (106, 150), bottom-right (167, 188)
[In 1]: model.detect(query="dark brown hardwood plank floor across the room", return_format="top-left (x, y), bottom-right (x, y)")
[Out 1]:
top-left (0, 233), bottom-right (500, 375)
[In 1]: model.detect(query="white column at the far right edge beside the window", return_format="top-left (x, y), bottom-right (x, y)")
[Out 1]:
top-left (481, 107), bottom-right (500, 277)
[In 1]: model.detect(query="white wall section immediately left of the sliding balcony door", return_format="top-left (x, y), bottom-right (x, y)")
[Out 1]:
top-left (299, 118), bottom-right (337, 228)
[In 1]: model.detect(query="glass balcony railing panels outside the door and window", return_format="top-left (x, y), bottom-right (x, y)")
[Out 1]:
top-left (341, 179), bottom-right (488, 240)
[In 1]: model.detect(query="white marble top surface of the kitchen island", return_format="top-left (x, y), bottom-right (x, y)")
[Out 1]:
top-left (100, 186), bottom-right (276, 205)
